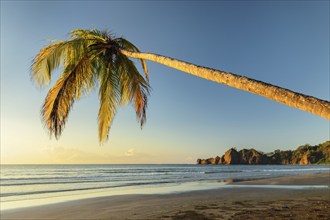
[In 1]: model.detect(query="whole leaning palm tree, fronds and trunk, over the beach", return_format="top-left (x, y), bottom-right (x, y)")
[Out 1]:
top-left (31, 29), bottom-right (330, 142)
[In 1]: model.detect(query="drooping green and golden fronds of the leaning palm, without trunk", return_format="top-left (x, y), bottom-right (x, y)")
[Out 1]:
top-left (31, 29), bottom-right (150, 142)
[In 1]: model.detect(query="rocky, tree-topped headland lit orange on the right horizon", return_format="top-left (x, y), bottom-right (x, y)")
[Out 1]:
top-left (197, 141), bottom-right (330, 165)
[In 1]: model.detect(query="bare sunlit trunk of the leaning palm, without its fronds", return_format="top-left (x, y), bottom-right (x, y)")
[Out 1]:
top-left (120, 49), bottom-right (330, 120)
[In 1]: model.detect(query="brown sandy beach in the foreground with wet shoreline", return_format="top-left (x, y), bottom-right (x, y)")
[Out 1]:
top-left (1, 173), bottom-right (330, 220)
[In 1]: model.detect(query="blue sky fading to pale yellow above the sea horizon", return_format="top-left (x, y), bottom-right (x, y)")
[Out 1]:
top-left (1, 0), bottom-right (330, 164)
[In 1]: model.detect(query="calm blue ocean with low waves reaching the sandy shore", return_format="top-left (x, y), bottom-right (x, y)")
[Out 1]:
top-left (0, 164), bottom-right (330, 210)
